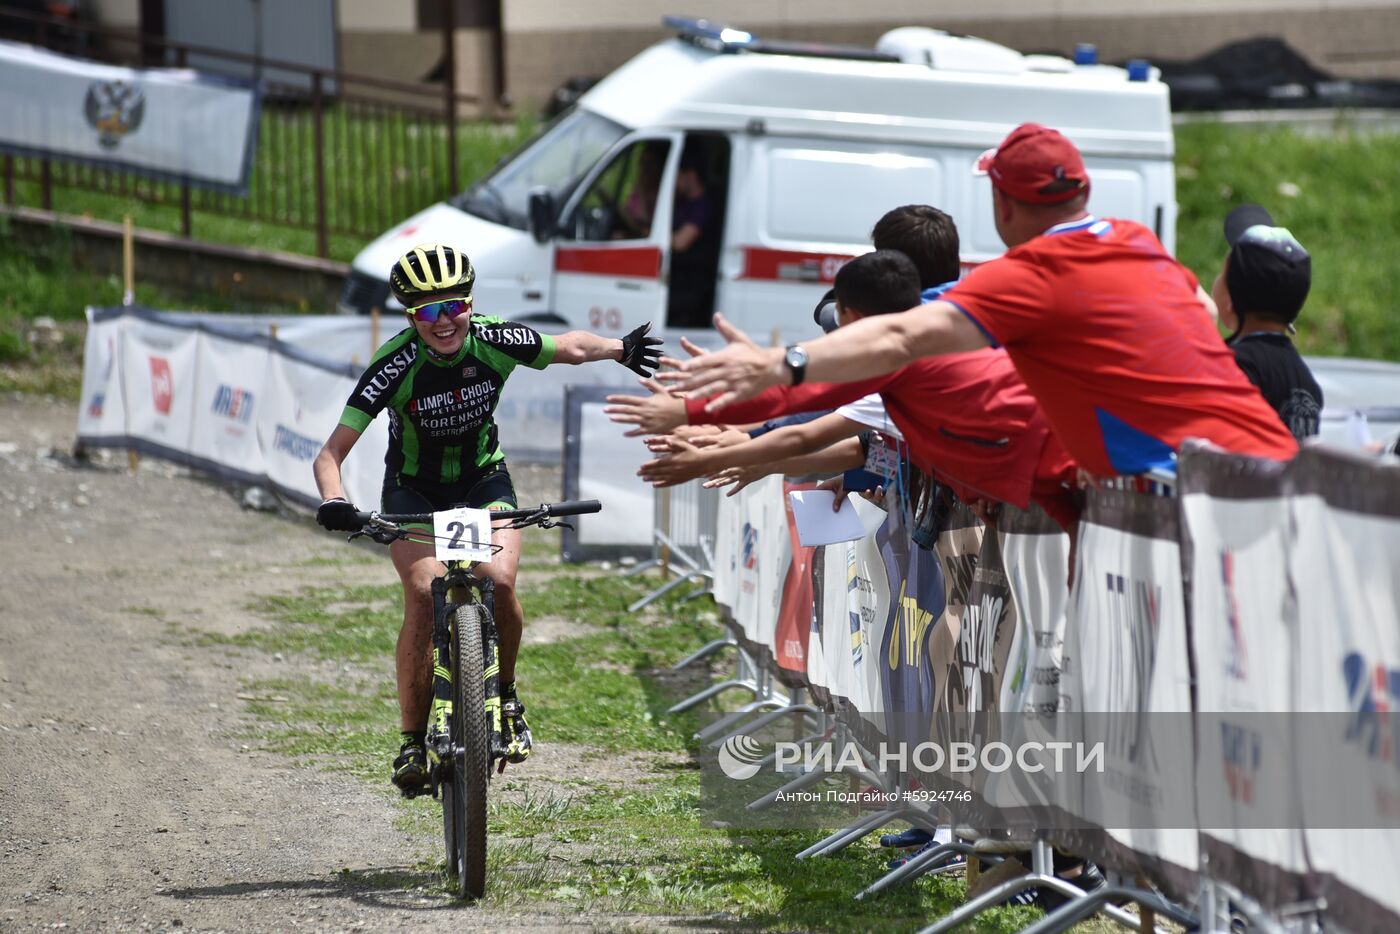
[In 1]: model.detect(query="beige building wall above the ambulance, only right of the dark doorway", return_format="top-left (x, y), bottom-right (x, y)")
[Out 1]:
top-left (504, 0), bottom-right (1400, 105)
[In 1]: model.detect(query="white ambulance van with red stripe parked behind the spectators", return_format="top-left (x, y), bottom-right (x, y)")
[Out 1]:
top-left (340, 18), bottom-right (1176, 336)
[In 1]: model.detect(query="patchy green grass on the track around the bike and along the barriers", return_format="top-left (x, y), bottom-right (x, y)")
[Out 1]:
top-left (218, 559), bottom-right (1052, 931)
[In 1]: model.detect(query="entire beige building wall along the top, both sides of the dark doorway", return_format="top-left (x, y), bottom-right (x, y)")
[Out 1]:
top-left (79, 0), bottom-right (1400, 109)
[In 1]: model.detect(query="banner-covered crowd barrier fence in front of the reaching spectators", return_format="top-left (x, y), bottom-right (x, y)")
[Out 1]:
top-left (678, 445), bottom-right (1400, 931)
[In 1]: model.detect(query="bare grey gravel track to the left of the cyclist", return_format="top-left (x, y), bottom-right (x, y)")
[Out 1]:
top-left (0, 396), bottom-right (602, 931)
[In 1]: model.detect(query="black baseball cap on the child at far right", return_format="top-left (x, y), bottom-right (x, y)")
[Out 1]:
top-left (1225, 204), bottom-right (1312, 325)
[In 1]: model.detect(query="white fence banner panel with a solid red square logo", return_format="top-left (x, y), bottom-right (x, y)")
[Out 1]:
top-left (118, 318), bottom-right (199, 459)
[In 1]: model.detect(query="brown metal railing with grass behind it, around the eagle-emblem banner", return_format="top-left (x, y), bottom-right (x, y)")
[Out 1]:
top-left (0, 3), bottom-right (501, 256)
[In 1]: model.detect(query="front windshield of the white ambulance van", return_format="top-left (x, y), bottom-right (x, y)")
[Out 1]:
top-left (452, 108), bottom-right (627, 230)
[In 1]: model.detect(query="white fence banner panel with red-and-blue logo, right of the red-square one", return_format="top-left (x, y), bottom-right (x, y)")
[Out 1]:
top-left (189, 333), bottom-right (269, 480)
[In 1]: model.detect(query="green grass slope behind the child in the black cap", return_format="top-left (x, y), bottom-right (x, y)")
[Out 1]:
top-left (1176, 118), bottom-right (1400, 360)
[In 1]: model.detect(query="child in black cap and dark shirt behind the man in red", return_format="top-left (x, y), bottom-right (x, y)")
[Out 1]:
top-left (1211, 204), bottom-right (1323, 441)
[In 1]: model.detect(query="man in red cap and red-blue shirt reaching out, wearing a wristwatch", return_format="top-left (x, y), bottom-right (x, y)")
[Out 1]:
top-left (662, 123), bottom-right (1298, 476)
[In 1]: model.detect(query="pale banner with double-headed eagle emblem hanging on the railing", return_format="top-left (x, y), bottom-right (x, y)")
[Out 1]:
top-left (0, 42), bottom-right (259, 195)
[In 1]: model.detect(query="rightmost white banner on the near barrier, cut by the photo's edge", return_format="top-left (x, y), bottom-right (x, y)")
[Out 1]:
top-left (1287, 448), bottom-right (1400, 931)
